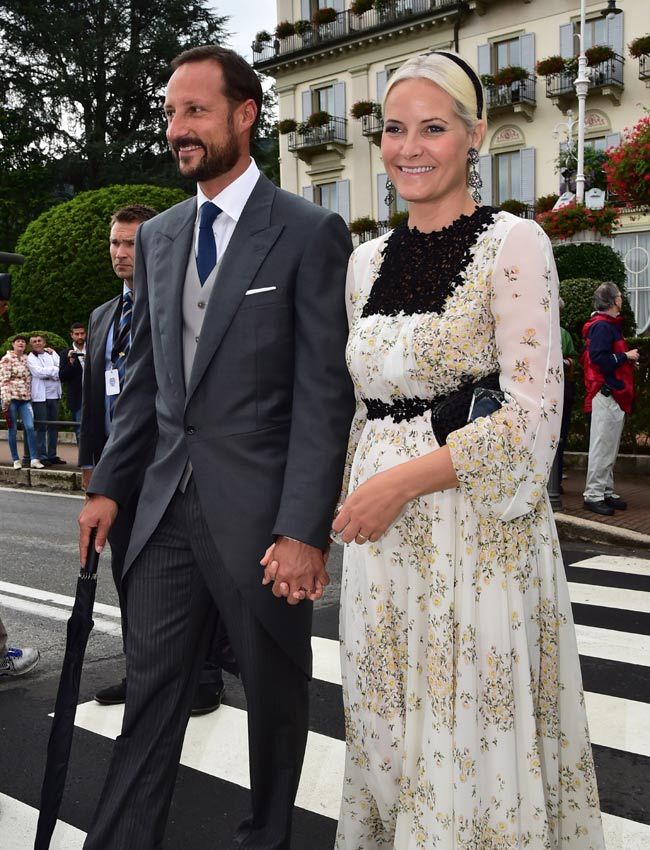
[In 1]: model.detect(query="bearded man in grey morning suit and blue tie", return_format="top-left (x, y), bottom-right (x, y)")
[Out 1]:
top-left (79, 47), bottom-right (354, 850)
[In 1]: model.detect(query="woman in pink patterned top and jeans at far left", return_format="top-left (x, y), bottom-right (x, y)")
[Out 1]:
top-left (0, 335), bottom-right (44, 469)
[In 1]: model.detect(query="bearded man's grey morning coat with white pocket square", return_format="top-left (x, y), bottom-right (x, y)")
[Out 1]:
top-left (89, 176), bottom-right (354, 674)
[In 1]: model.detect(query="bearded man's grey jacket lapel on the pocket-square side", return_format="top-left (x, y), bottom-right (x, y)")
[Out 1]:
top-left (184, 176), bottom-right (284, 405)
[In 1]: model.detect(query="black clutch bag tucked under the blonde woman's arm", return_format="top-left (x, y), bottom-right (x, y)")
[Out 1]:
top-left (431, 372), bottom-right (505, 446)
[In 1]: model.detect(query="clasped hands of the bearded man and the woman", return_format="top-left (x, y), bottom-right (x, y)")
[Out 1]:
top-left (261, 537), bottom-right (329, 605)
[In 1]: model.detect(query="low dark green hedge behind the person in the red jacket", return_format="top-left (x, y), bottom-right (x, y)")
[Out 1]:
top-left (567, 336), bottom-right (650, 454)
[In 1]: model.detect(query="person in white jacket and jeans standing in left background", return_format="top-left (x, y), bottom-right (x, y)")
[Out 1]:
top-left (27, 334), bottom-right (65, 466)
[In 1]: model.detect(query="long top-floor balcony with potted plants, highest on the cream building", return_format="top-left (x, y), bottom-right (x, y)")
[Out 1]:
top-left (252, 0), bottom-right (467, 71)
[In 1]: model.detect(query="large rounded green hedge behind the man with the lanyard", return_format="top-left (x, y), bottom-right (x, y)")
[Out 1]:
top-left (9, 185), bottom-right (187, 338)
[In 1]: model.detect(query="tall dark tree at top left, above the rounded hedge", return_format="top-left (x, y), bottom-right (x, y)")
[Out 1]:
top-left (0, 0), bottom-right (226, 188)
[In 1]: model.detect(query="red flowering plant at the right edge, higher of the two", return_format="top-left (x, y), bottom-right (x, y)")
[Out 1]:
top-left (603, 115), bottom-right (650, 207)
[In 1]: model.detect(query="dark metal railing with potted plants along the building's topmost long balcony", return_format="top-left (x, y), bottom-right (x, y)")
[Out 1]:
top-left (252, 0), bottom-right (465, 67)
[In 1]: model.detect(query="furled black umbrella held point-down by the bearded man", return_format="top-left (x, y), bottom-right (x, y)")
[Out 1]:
top-left (34, 531), bottom-right (99, 850)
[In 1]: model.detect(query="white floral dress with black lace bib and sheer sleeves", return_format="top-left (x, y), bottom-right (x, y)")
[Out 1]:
top-left (336, 207), bottom-right (605, 850)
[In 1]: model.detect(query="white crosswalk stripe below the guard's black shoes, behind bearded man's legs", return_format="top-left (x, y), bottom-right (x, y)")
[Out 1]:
top-left (68, 702), bottom-right (345, 818)
